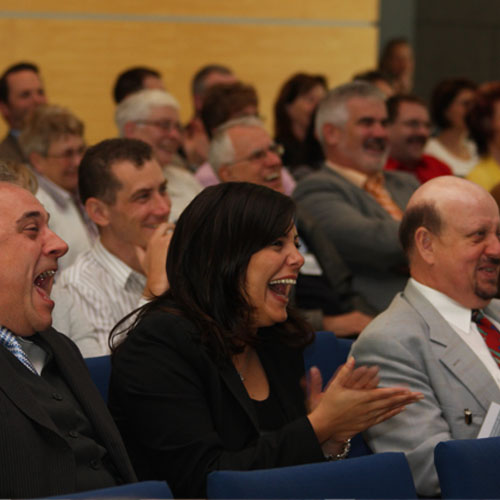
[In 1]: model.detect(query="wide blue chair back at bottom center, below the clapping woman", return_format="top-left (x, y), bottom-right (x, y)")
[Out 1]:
top-left (207, 453), bottom-right (417, 499)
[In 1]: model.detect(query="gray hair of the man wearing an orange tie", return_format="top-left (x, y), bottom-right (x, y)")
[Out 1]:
top-left (315, 81), bottom-right (385, 145)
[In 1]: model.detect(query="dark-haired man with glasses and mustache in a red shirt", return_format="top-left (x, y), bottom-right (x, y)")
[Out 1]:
top-left (385, 94), bottom-right (452, 183)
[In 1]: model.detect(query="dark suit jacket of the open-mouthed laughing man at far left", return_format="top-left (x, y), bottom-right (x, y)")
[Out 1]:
top-left (0, 329), bottom-right (136, 498)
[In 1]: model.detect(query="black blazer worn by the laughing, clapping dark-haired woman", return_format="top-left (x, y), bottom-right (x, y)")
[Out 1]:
top-left (109, 311), bottom-right (323, 498)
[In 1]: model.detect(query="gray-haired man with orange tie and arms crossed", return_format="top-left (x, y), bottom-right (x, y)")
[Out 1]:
top-left (294, 82), bottom-right (419, 311)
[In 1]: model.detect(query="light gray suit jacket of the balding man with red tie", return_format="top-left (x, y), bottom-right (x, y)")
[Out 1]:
top-left (352, 282), bottom-right (500, 496)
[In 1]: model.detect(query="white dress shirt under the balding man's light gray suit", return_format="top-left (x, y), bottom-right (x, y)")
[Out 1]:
top-left (410, 278), bottom-right (500, 388)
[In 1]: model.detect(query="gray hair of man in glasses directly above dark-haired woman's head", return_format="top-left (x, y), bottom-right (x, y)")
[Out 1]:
top-left (208, 116), bottom-right (264, 175)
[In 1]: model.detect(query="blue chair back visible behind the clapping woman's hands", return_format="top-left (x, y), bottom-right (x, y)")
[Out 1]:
top-left (304, 332), bottom-right (373, 458)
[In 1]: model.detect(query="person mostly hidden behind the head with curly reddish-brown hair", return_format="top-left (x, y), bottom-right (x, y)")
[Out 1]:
top-left (182, 64), bottom-right (238, 171)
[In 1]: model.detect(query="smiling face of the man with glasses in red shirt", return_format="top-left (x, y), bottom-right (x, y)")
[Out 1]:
top-left (388, 101), bottom-right (431, 165)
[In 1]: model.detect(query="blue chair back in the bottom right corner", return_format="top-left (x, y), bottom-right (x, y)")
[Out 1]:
top-left (434, 437), bottom-right (500, 498)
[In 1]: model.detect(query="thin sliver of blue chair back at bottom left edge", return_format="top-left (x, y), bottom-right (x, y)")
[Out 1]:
top-left (36, 481), bottom-right (174, 500)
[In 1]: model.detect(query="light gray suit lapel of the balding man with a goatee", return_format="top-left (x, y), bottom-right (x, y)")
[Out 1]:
top-left (404, 283), bottom-right (500, 410)
